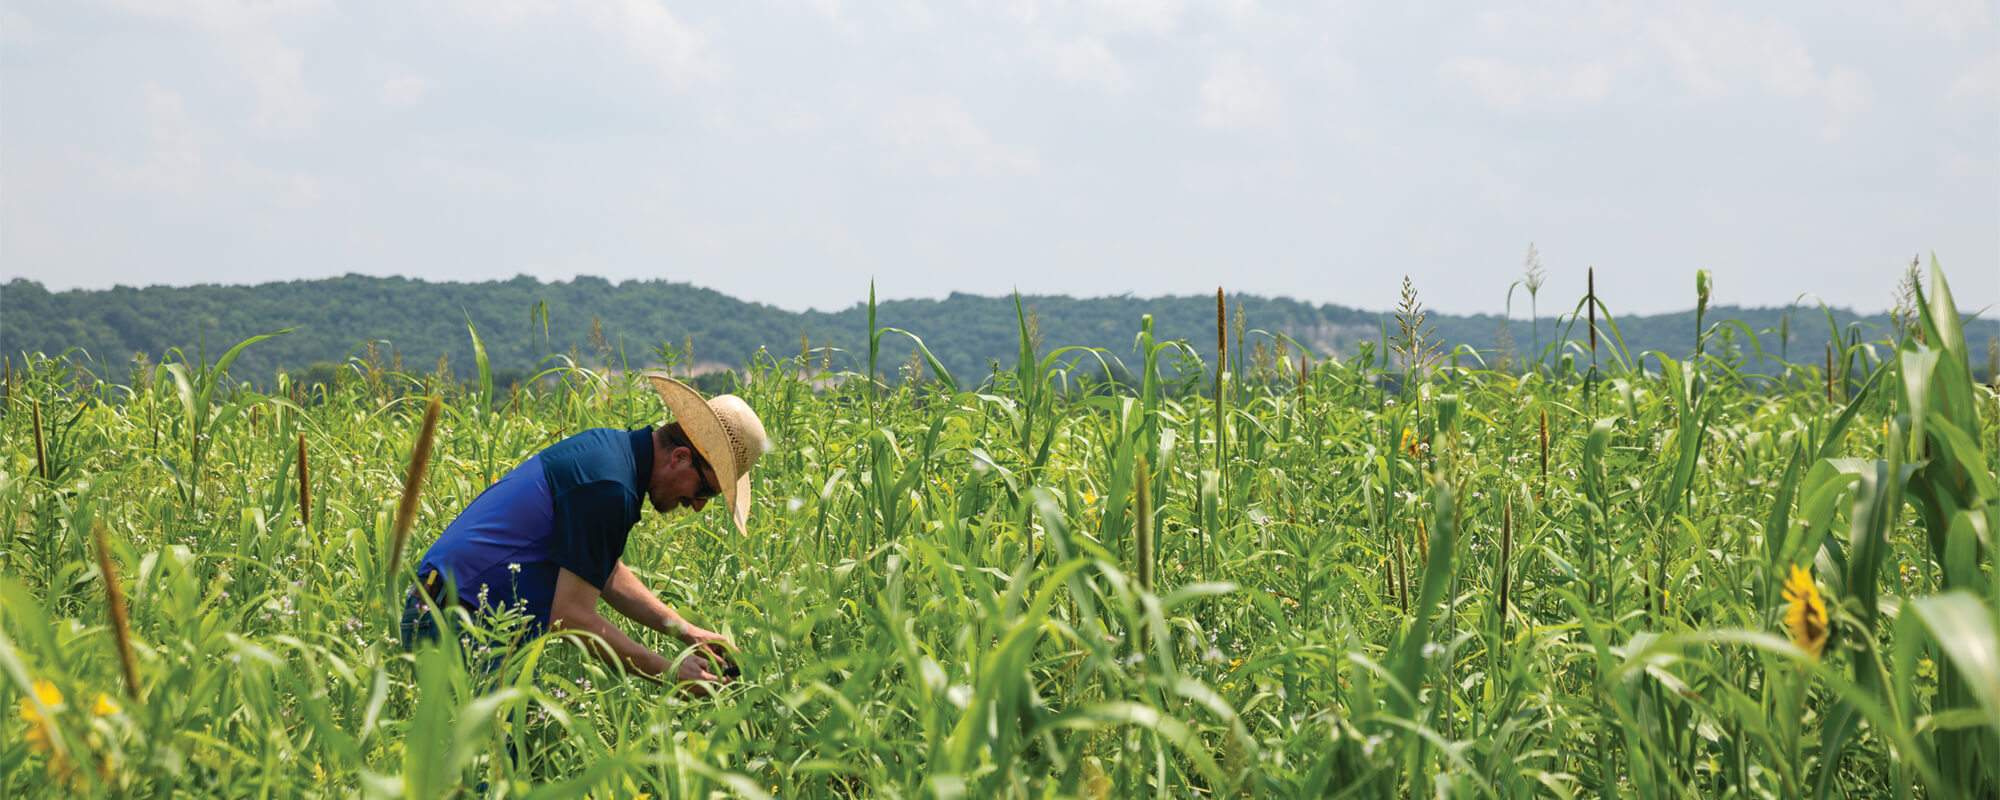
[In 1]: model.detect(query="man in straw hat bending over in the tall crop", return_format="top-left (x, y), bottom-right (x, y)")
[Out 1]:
top-left (402, 372), bottom-right (770, 694)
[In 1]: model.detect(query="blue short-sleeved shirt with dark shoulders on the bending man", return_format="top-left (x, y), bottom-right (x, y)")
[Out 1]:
top-left (416, 428), bottom-right (652, 626)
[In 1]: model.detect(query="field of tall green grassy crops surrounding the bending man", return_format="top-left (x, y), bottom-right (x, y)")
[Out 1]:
top-left (0, 268), bottom-right (2000, 798)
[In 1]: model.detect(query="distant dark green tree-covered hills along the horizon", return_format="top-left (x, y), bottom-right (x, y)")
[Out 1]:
top-left (0, 274), bottom-right (2000, 382)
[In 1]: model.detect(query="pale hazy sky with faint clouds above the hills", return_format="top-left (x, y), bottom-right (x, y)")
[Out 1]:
top-left (0, 0), bottom-right (2000, 316)
